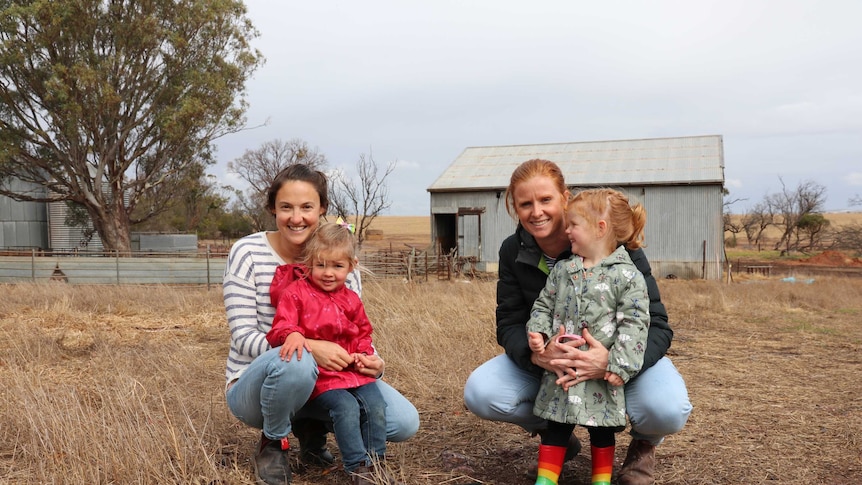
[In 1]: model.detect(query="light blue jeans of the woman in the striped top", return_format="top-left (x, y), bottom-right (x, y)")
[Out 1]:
top-left (226, 347), bottom-right (419, 441)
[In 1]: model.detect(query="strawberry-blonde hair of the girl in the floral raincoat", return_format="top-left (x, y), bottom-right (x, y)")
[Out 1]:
top-left (566, 189), bottom-right (646, 250)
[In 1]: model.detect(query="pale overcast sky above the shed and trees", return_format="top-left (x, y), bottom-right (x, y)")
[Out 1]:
top-left (212, 0), bottom-right (862, 215)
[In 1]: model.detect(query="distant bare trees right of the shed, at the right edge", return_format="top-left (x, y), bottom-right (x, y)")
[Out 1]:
top-left (724, 177), bottom-right (862, 255)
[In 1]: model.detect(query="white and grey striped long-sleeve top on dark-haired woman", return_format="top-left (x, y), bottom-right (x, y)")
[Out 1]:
top-left (222, 232), bottom-right (362, 383)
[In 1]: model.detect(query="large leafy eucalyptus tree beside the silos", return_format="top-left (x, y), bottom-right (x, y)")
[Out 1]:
top-left (0, 0), bottom-right (263, 251)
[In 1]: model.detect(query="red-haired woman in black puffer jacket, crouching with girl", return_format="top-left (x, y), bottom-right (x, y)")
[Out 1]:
top-left (464, 160), bottom-right (691, 485)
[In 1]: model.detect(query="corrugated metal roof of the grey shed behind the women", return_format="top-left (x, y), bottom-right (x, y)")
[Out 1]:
top-left (428, 135), bottom-right (724, 192)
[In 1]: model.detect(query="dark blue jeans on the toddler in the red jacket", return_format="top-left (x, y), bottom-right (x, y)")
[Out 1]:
top-left (309, 382), bottom-right (386, 472)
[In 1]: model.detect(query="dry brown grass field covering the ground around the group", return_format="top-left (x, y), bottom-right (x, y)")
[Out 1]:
top-left (0, 278), bottom-right (862, 485)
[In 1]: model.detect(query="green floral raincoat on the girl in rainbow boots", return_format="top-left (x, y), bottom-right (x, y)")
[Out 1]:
top-left (527, 246), bottom-right (650, 427)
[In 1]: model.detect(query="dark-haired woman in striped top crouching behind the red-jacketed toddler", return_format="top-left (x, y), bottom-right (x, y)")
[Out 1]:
top-left (223, 164), bottom-right (419, 485)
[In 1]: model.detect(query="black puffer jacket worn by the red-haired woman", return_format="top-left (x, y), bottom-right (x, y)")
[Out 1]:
top-left (497, 224), bottom-right (673, 378)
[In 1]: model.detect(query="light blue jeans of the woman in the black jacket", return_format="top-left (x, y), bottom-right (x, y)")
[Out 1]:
top-left (464, 354), bottom-right (691, 445)
